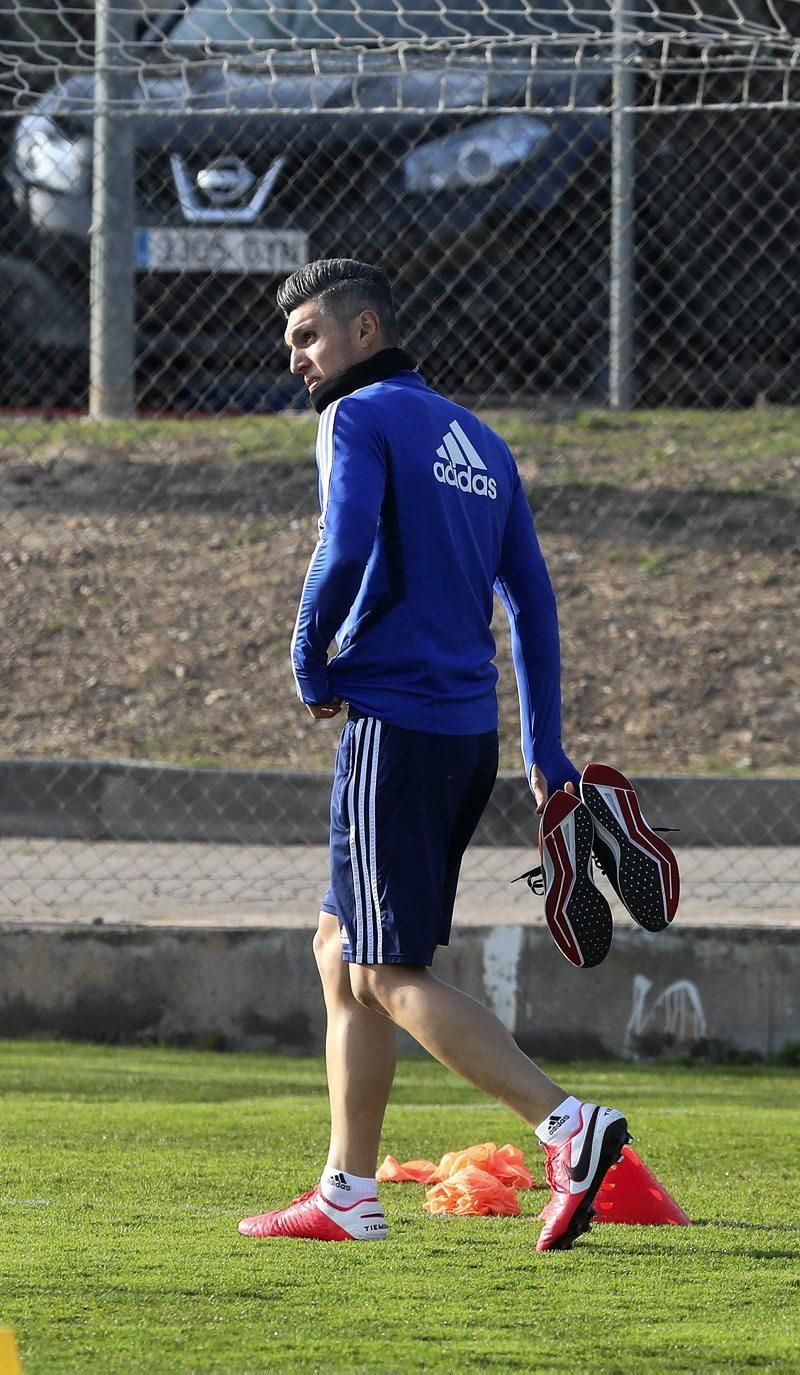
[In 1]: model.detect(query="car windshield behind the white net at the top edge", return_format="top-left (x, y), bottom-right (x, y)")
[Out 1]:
top-left (169, 0), bottom-right (609, 48)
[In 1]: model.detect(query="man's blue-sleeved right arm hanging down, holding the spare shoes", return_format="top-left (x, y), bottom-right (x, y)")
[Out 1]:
top-left (495, 474), bottom-right (580, 800)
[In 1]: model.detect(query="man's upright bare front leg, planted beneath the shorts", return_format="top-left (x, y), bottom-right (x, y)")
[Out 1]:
top-left (313, 912), bottom-right (397, 1178)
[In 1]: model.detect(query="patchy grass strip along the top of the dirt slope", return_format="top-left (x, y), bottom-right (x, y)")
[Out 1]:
top-left (0, 406), bottom-right (800, 501)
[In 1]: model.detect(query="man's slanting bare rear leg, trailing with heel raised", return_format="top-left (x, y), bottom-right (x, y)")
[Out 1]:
top-left (349, 964), bottom-right (566, 1126)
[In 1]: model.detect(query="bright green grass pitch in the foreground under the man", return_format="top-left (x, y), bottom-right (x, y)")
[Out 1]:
top-left (0, 1042), bottom-right (800, 1375)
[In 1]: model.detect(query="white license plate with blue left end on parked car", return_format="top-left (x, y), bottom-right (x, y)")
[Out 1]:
top-left (136, 228), bottom-right (308, 276)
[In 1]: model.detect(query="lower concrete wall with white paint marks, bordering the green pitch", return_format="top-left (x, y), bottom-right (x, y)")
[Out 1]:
top-left (0, 925), bottom-right (800, 1057)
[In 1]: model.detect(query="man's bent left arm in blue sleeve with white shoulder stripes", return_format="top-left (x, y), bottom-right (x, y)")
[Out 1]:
top-left (291, 396), bottom-right (386, 715)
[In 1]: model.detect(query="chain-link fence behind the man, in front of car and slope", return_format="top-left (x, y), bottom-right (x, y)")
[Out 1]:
top-left (0, 0), bottom-right (800, 910)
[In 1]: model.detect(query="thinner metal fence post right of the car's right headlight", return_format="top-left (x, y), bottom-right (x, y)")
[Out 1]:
top-left (609, 0), bottom-right (636, 411)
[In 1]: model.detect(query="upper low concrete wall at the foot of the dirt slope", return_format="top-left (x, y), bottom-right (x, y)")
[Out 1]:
top-left (0, 759), bottom-right (800, 847)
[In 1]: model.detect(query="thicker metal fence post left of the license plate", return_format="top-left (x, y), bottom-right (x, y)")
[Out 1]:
top-left (89, 0), bottom-right (136, 419)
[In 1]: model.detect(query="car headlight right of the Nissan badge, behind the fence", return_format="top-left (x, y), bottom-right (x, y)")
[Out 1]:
top-left (403, 114), bottom-right (550, 191)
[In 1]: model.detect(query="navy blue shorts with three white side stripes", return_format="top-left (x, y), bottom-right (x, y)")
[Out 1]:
top-left (322, 708), bottom-right (498, 964)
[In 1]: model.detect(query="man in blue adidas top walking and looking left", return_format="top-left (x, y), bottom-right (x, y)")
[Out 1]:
top-left (239, 259), bottom-right (628, 1251)
